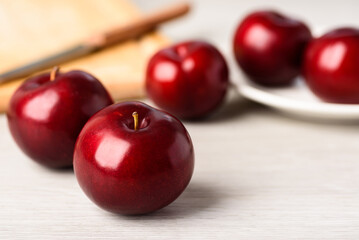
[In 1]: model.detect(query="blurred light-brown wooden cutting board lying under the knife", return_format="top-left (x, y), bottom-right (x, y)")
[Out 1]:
top-left (0, 0), bottom-right (169, 112)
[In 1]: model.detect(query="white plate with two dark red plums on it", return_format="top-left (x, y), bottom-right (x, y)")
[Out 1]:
top-left (231, 62), bottom-right (359, 120)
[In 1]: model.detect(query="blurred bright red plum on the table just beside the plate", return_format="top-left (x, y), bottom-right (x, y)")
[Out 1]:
top-left (146, 41), bottom-right (229, 119)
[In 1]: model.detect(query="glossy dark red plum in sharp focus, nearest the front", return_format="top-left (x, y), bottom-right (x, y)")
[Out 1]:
top-left (74, 102), bottom-right (194, 215)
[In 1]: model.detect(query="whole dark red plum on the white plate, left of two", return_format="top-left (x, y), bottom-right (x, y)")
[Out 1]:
top-left (233, 11), bottom-right (312, 87)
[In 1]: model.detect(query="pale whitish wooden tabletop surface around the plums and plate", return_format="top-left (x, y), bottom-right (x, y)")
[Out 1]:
top-left (0, 0), bottom-right (359, 240)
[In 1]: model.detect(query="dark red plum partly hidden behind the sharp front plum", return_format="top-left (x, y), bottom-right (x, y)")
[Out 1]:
top-left (7, 71), bottom-right (113, 168)
